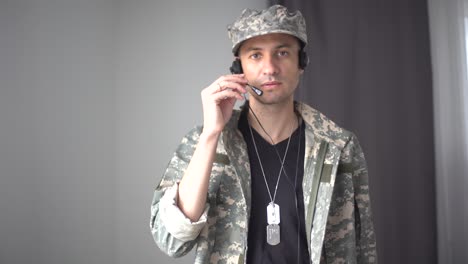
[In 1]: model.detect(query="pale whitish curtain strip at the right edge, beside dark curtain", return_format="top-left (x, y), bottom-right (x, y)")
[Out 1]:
top-left (428, 0), bottom-right (468, 263)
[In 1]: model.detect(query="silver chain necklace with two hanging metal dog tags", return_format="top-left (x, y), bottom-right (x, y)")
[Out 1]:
top-left (249, 119), bottom-right (292, 246)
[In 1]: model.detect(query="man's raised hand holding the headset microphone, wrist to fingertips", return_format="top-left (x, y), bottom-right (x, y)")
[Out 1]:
top-left (201, 74), bottom-right (247, 135)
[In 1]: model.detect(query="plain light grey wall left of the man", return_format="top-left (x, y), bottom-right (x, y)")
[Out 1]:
top-left (0, 0), bottom-right (265, 264)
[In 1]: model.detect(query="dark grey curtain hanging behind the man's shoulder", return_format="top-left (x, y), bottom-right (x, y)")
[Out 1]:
top-left (269, 0), bottom-right (437, 264)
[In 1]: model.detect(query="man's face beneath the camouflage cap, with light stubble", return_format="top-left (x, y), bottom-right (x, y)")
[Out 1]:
top-left (239, 33), bottom-right (303, 104)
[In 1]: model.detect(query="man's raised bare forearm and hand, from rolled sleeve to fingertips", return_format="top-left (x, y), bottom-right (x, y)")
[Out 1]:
top-left (178, 74), bottom-right (247, 222)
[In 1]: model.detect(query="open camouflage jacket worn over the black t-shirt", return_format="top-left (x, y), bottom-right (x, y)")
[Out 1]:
top-left (150, 103), bottom-right (377, 264)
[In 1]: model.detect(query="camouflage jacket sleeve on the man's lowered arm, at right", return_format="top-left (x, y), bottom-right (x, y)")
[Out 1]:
top-left (322, 134), bottom-right (377, 264)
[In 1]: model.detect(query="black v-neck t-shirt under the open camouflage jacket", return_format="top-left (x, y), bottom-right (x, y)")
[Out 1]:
top-left (238, 108), bottom-right (310, 264)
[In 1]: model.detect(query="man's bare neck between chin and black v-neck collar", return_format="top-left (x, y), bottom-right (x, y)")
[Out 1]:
top-left (248, 100), bottom-right (298, 144)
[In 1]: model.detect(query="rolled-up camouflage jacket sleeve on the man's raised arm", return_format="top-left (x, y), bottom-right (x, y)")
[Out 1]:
top-left (150, 128), bottom-right (209, 257)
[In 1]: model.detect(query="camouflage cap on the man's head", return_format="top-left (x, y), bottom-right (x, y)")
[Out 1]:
top-left (228, 5), bottom-right (307, 54)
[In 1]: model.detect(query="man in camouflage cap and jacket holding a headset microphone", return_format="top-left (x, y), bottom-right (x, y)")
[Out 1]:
top-left (150, 5), bottom-right (377, 263)
